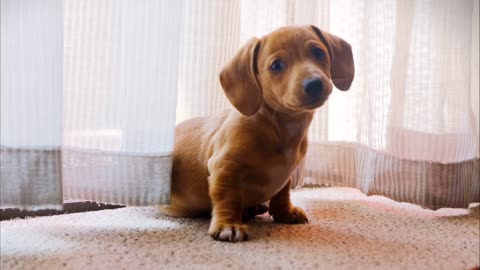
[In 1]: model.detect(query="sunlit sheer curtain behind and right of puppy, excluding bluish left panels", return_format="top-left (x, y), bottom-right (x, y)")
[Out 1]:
top-left (177, 0), bottom-right (480, 209)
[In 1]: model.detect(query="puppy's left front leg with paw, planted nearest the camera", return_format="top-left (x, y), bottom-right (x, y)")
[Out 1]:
top-left (208, 171), bottom-right (248, 242)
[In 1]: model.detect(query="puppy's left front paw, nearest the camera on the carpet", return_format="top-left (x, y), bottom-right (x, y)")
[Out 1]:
top-left (208, 222), bottom-right (248, 242)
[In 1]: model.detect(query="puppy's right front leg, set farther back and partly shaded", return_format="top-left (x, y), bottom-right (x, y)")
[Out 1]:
top-left (268, 180), bottom-right (308, 224)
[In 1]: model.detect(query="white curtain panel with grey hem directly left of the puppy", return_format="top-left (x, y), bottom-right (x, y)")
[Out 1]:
top-left (63, 0), bottom-right (183, 205)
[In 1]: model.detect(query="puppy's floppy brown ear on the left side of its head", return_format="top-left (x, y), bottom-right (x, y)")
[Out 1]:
top-left (220, 38), bottom-right (263, 116)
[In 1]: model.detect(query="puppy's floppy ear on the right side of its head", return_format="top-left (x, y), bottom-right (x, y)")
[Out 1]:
top-left (310, 25), bottom-right (355, 91)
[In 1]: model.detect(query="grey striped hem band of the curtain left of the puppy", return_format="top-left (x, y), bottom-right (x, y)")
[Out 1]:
top-left (0, 147), bottom-right (172, 211)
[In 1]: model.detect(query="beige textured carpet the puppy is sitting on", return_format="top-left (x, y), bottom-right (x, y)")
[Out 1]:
top-left (0, 188), bottom-right (480, 270)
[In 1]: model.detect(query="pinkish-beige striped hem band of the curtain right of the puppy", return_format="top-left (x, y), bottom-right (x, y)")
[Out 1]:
top-left (293, 143), bottom-right (480, 209)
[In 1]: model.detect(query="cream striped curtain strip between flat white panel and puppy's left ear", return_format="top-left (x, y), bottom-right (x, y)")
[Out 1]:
top-left (176, 0), bottom-right (241, 123)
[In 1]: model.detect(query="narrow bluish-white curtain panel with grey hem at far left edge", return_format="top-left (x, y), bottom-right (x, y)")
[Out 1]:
top-left (0, 0), bottom-right (63, 210)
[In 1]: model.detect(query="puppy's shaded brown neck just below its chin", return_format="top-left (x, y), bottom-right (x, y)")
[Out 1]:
top-left (257, 102), bottom-right (314, 148)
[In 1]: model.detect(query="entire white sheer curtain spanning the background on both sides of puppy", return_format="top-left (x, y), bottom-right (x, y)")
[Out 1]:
top-left (0, 0), bottom-right (480, 209)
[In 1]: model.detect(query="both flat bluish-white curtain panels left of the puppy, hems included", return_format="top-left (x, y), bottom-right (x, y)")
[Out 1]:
top-left (0, 0), bottom-right (183, 209)
